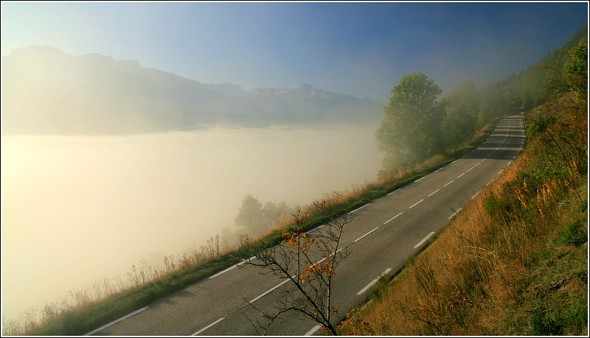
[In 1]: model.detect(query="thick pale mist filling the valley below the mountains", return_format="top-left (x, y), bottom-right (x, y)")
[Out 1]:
top-left (2, 127), bottom-right (382, 318)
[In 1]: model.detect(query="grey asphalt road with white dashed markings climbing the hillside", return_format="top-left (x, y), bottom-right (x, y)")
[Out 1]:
top-left (88, 116), bottom-right (525, 336)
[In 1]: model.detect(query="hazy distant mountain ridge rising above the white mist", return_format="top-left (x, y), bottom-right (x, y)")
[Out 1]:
top-left (2, 46), bottom-right (383, 134)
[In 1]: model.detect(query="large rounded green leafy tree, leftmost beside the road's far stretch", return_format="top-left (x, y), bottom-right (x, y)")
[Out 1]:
top-left (376, 73), bottom-right (443, 170)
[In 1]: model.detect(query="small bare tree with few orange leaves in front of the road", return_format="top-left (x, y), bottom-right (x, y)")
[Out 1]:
top-left (247, 201), bottom-right (352, 335)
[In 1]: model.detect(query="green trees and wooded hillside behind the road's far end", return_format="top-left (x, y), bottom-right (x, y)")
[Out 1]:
top-left (376, 27), bottom-right (586, 171)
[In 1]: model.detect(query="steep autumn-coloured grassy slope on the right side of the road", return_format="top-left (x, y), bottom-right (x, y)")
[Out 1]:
top-left (339, 93), bottom-right (588, 335)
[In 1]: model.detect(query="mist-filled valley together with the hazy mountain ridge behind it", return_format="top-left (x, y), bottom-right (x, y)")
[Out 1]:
top-left (2, 48), bottom-right (381, 318)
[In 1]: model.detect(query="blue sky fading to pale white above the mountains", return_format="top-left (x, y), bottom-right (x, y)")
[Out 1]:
top-left (1, 1), bottom-right (588, 103)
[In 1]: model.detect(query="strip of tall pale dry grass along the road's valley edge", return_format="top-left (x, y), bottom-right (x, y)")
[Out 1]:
top-left (2, 122), bottom-right (494, 335)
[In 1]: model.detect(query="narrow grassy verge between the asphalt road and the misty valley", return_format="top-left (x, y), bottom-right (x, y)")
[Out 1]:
top-left (2, 120), bottom-right (497, 335)
